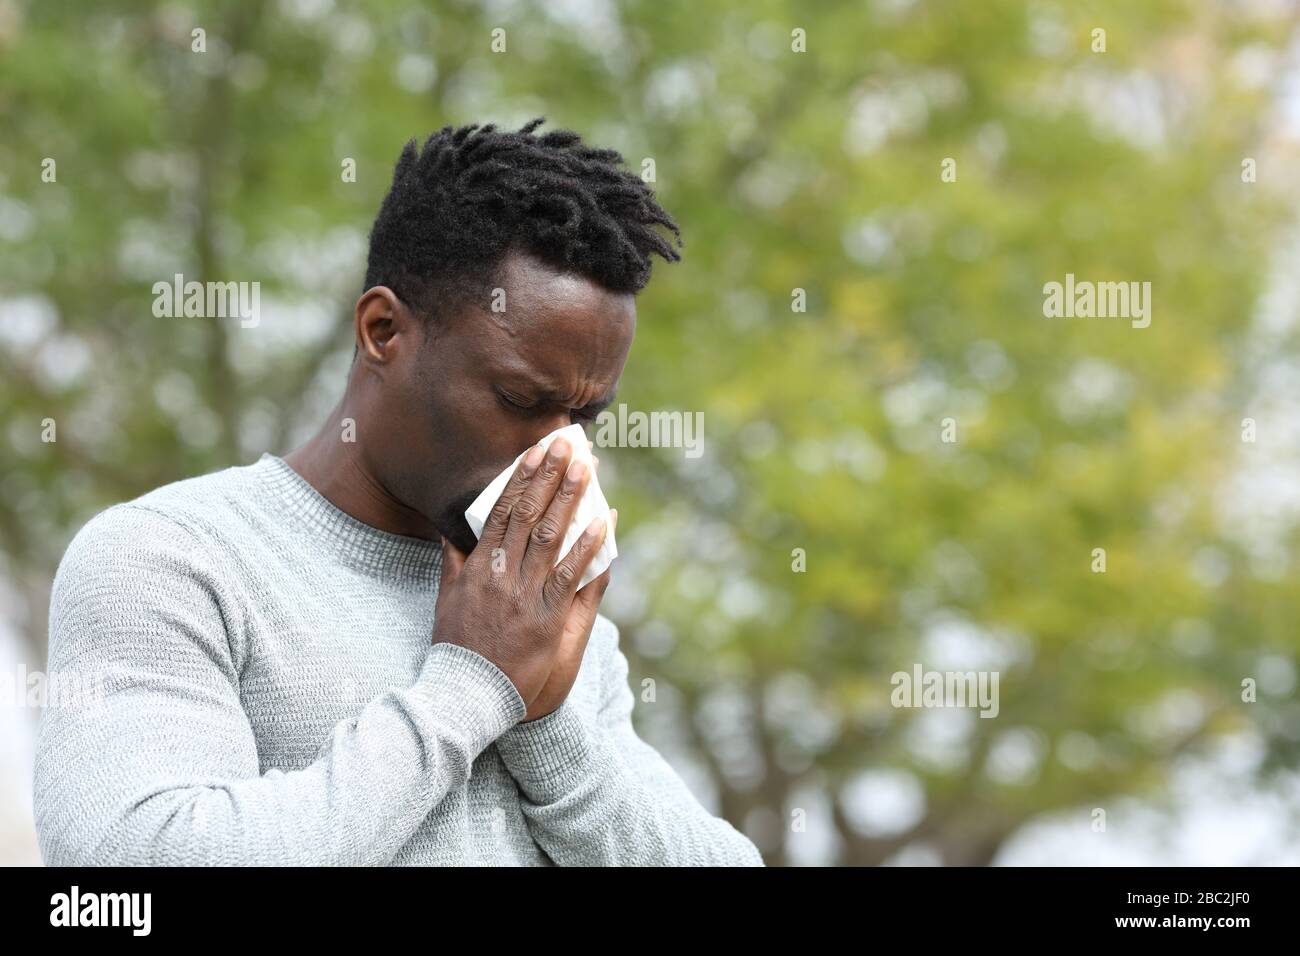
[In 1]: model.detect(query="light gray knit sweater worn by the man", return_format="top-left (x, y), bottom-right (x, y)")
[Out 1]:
top-left (35, 455), bottom-right (762, 866)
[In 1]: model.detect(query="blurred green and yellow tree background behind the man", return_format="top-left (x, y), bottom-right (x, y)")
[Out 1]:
top-left (0, 0), bottom-right (1300, 865)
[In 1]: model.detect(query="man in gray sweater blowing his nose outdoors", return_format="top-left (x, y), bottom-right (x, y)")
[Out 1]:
top-left (35, 120), bottom-right (762, 865)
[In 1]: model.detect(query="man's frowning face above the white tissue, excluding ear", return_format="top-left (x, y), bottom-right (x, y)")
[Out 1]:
top-left (372, 254), bottom-right (636, 554)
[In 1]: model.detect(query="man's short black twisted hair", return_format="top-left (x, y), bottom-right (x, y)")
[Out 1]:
top-left (365, 117), bottom-right (681, 321)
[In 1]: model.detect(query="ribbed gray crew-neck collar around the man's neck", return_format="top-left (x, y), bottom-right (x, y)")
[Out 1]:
top-left (252, 453), bottom-right (442, 580)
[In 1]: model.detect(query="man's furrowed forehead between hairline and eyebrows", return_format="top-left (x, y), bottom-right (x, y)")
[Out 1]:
top-left (462, 254), bottom-right (636, 393)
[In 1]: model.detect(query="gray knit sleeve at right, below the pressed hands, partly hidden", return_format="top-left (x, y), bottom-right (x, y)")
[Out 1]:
top-left (497, 622), bottom-right (763, 866)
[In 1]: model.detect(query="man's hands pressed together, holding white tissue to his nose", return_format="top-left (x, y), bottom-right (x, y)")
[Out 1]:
top-left (433, 438), bottom-right (608, 721)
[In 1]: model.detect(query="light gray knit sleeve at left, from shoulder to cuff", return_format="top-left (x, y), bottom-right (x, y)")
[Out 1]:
top-left (34, 506), bottom-right (527, 866)
